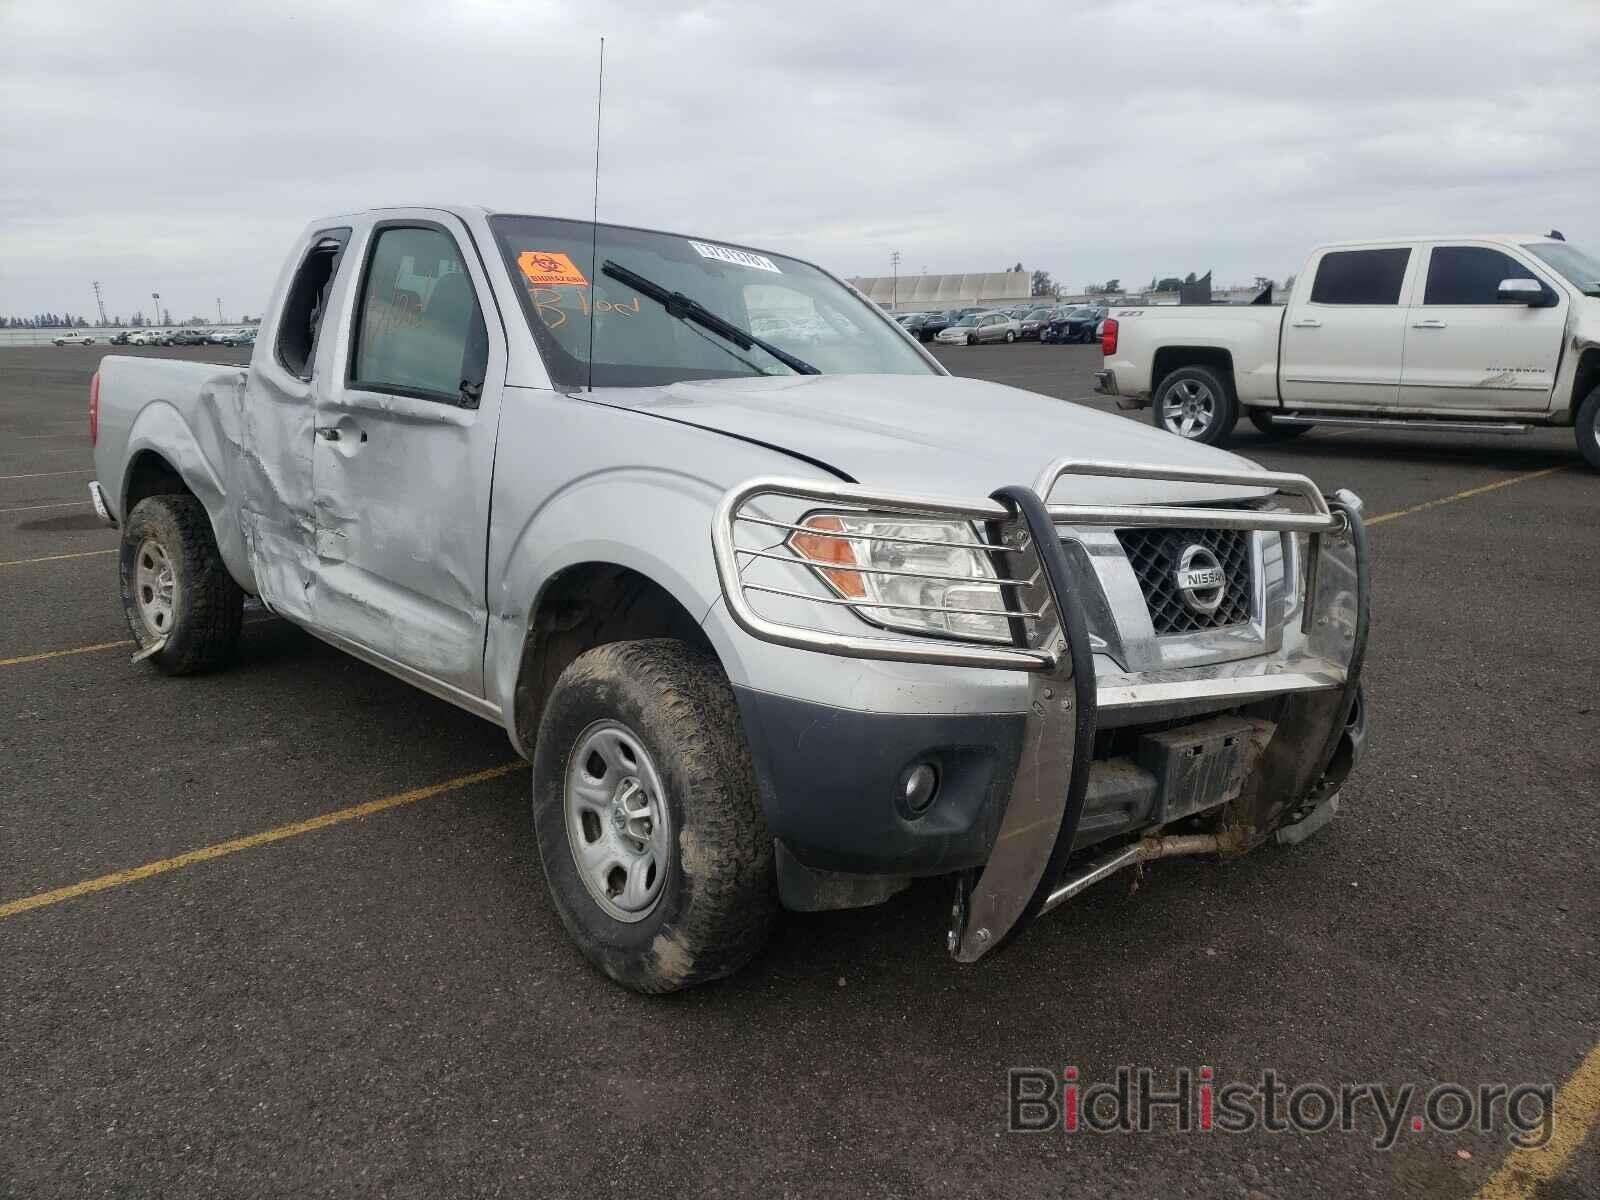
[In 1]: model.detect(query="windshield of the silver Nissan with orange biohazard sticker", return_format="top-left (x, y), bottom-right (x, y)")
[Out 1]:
top-left (490, 216), bottom-right (936, 389)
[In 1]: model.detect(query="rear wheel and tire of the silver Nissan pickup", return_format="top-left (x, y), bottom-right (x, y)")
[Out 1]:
top-left (117, 496), bottom-right (245, 675)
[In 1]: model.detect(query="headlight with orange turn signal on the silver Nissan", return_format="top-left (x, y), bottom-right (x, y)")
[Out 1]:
top-left (789, 512), bottom-right (1011, 642)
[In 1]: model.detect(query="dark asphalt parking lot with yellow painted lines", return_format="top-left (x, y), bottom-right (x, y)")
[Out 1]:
top-left (0, 346), bottom-right (1600, 1200)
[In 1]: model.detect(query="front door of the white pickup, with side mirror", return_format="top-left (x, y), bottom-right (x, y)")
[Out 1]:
top-left (1400, 243), bottom-right (1568, 413)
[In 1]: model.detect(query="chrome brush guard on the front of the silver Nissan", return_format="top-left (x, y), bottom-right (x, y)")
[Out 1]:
top-left (712, 459), bottom-right (1365, 962)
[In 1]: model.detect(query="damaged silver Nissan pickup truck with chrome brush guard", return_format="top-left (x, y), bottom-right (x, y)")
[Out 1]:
top-left (90, 208), bottom-right (1368, 992)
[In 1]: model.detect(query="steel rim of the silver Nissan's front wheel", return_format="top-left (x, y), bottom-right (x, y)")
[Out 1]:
top-left (565, 720), bottom-right (672, 923)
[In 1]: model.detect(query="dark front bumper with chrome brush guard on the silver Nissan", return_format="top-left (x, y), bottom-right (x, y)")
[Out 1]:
top-left (712, 461), bottom-right (1366, 962)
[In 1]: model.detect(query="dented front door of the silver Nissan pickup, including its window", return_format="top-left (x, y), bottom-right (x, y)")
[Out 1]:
top-left (312, 214), bottom-right (506, 699)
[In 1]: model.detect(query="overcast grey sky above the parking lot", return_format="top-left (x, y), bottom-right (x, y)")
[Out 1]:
top-left (0, 0), bottom-right (1600, 318)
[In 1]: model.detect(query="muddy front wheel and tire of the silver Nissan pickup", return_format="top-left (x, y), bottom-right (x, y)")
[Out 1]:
top-left (533, 638), bottom-right (778, 994)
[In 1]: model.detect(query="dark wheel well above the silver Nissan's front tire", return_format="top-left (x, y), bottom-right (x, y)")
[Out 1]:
top-left (514, 563), bottom-right (715, 752)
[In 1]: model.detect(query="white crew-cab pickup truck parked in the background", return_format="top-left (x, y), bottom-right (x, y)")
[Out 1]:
top-left (1098, 234), bottom-right (1600, 470)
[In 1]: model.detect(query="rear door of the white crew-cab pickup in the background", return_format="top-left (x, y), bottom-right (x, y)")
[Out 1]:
top-left (1278, 246), bottom-right (1416, 408)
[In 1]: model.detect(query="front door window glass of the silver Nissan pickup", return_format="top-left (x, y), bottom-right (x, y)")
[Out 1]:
top-left (350, 227), bottom-right (488, 406)
